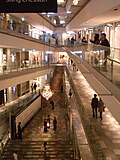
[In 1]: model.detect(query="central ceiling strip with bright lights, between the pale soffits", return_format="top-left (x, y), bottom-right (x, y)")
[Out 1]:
top-left (40, 0), bottom-right (90, 27)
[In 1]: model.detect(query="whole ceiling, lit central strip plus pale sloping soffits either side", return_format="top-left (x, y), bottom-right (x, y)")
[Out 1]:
top-left (11, 0), bottom-right (120, 32)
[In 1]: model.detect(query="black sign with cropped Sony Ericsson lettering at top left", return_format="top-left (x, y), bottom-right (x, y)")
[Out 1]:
top-left (0, 0), bottom-right (57, 13)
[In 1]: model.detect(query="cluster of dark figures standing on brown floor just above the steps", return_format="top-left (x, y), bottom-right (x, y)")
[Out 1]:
top-left (44, 115), bottom-right (57, 133)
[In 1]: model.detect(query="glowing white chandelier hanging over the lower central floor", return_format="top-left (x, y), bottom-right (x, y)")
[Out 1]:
top-left (42, 84), bottom-right (53, 100)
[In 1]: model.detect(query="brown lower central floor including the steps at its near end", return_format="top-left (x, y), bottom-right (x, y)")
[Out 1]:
top-left (2, 67), bottom-right (74, 160)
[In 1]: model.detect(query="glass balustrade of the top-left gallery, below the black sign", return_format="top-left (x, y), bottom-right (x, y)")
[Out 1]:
top-left (0, 19), bottom-right (56, 45)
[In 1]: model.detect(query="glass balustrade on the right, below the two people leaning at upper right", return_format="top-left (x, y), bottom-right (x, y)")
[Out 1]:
top-left (72, 43), bottom-right (120, 87)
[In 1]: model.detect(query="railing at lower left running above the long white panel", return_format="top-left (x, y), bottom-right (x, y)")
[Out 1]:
top-left (0, 90), bottom-right (40, 152)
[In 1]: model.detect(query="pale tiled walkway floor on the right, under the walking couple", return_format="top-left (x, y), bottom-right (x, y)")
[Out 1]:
top-left (69, 67), bottom-right (120, 160)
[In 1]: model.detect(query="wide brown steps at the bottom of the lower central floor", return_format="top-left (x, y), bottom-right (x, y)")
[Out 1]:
top-left (1, 140), bottom-right (74, 160)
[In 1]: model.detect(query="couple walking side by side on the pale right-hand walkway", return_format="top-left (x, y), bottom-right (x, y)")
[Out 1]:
top-left (91, 94), bottom-right (105, 121)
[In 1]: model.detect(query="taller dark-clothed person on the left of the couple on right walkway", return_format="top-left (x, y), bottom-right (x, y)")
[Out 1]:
top-left (91, 94), bottom-right (98, 119)
